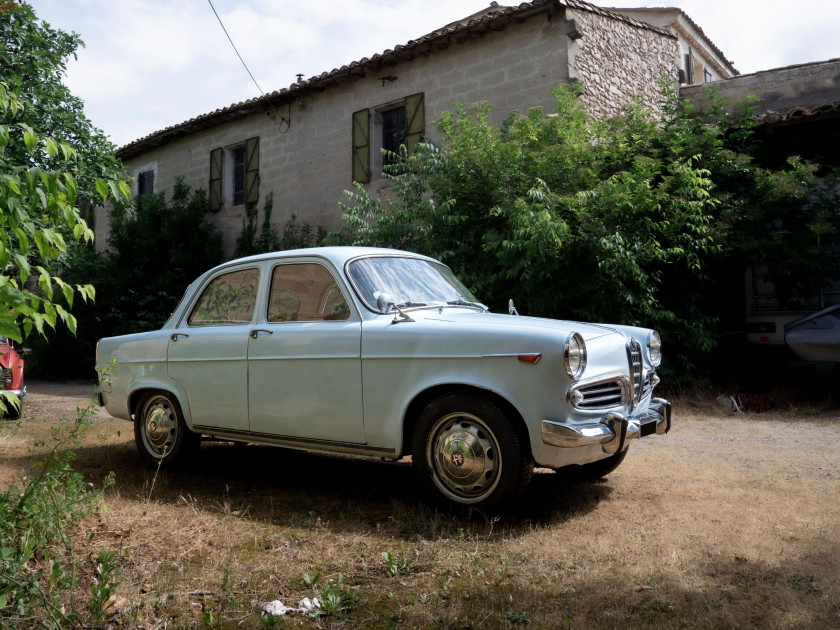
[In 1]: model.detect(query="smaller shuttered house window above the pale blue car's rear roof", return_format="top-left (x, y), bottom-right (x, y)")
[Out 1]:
top-left (209, 138), bottom-right (260, 212)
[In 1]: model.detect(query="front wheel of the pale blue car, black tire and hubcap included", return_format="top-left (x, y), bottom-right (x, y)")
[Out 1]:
top-left (411, 394), bottom-right (534, 509)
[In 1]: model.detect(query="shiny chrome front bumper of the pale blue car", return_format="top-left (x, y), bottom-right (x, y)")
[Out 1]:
top-left (542, 398), bottom-right (671, 455)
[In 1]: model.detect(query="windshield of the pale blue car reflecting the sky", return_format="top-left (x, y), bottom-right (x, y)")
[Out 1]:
top-left (347, 256), bottom-right (484, 311)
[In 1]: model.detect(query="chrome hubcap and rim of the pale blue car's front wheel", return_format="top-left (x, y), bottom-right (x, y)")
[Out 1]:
top-left (426, 413), bottom-right (502, 503)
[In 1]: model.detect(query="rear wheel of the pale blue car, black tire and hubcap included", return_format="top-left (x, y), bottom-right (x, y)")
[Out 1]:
top-left (134, 392), bottom-right (200, 468)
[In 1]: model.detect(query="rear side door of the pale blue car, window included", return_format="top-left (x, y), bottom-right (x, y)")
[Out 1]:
top-left (167, 267), bottom-right (260, 431)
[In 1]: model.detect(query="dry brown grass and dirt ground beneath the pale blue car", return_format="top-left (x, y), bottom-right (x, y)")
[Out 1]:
top-left (0, 388), bottom-right (840, 629)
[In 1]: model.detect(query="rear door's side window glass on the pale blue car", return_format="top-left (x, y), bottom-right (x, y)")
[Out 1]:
top-left (187, 269), bottom-right (260, 326)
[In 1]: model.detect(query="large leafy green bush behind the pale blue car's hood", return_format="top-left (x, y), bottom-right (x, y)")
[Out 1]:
top-left (329, 88), bottom-right (840, 375)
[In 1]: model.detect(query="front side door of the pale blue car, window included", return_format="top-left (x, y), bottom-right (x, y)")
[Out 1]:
top-left (248, 261), bottom-right (365, 443)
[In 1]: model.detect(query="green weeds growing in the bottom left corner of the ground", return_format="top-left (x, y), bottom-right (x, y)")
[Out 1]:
top-left (0, 388), bottom-right (116, 629)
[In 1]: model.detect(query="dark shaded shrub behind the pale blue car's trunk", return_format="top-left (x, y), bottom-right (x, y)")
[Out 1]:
top-left (27, 179), bottom-right (223, 378)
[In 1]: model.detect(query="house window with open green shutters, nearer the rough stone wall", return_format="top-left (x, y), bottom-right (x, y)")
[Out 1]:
top-left (352, 93), bottom-right (426, 183)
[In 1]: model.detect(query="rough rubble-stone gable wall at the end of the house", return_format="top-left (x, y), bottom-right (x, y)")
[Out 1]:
top-left (567, 10), bottom-right (679, 118)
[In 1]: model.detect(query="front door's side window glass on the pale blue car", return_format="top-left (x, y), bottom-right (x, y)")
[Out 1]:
top-left (267, 263), bottom-right (350, 322)
